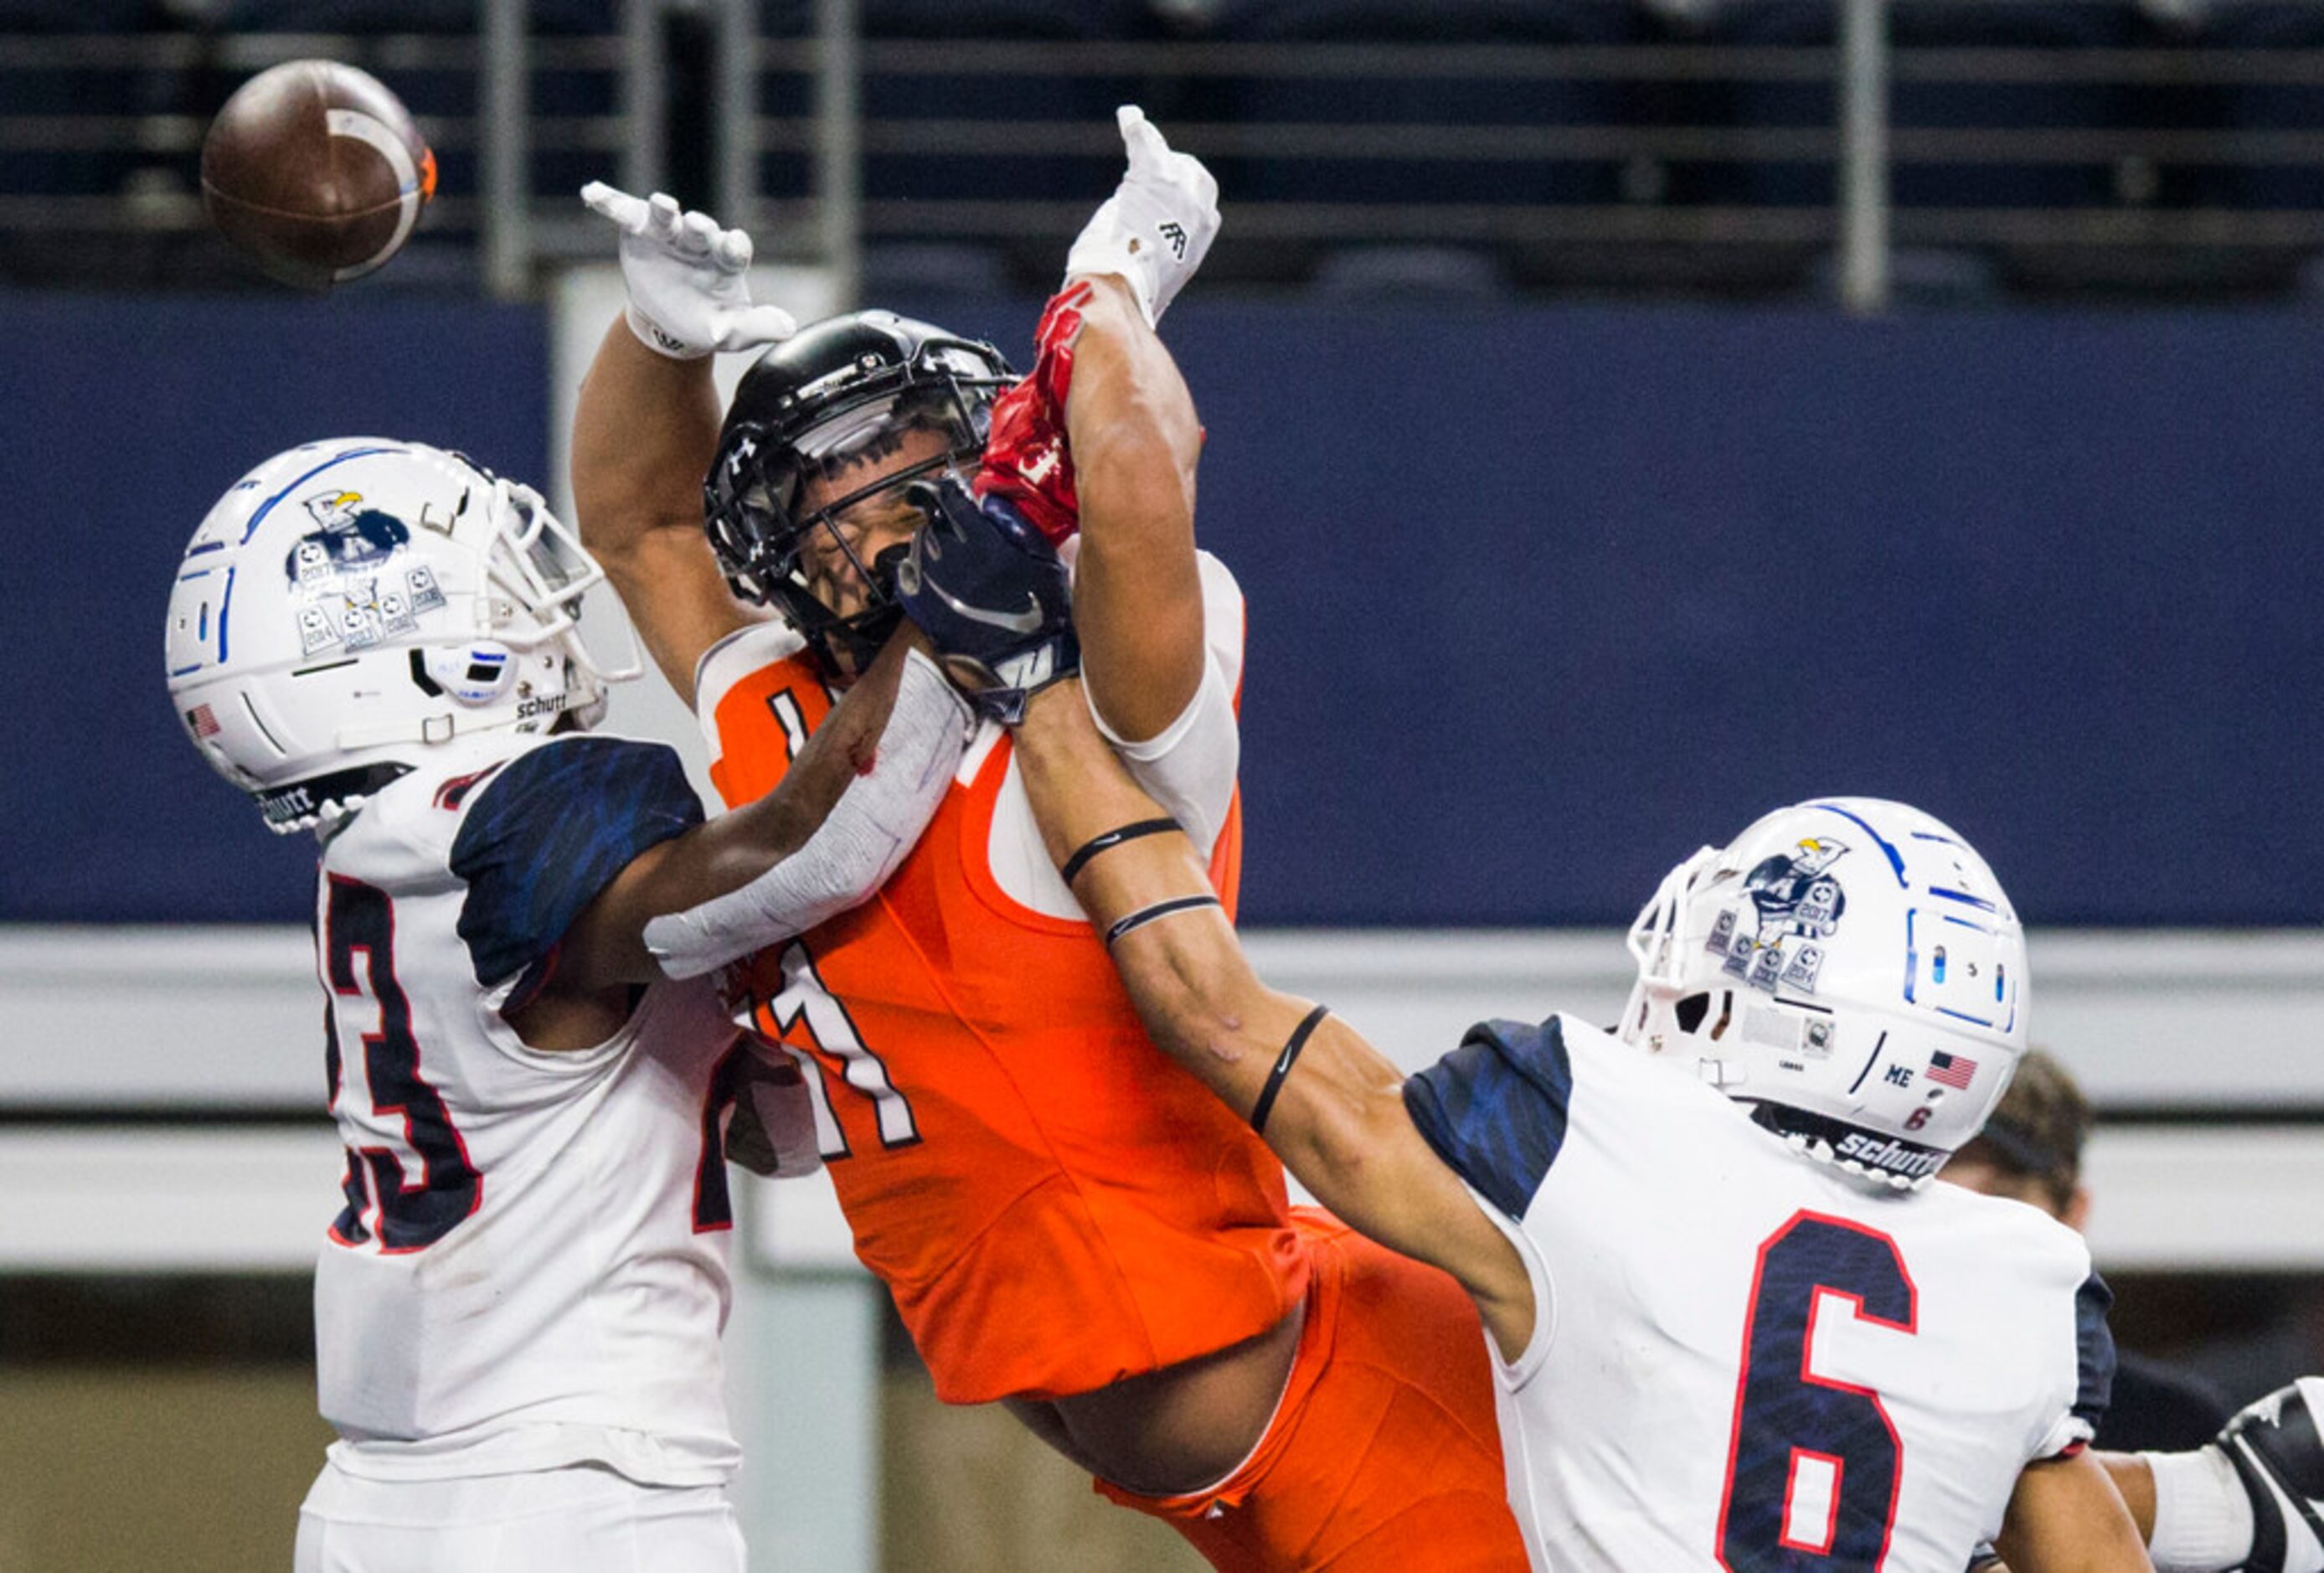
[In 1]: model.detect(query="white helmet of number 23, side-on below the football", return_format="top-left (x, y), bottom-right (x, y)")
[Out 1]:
top-left (167, 437), bottom-right (636, 832)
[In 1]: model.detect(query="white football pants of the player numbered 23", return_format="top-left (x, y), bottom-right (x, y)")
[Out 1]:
top-left (293, 1464), bottom-right (744, 1573)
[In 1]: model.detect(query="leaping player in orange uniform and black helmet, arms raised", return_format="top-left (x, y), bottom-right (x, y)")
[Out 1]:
top-left (574, 109), bottom-right (1524, 1573)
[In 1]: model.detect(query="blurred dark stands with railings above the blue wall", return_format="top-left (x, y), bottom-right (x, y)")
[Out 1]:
top-left (0, 0), bottom-right (2324, 304)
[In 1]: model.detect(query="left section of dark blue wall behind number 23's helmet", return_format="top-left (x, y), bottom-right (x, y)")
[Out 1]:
top-left (0, 295), bottom-right (549, 922)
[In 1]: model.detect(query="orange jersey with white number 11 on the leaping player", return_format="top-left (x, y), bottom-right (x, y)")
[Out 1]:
top-left (702, 613), bottom-right (1308, 1403)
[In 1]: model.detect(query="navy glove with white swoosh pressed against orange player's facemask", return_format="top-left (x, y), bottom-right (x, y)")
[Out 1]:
top-left (894, 477), bottom-right (1080, 727)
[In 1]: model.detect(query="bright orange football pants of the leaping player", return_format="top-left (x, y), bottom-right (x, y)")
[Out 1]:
top-left (1097, 1208), bottom-right (1524, 1573)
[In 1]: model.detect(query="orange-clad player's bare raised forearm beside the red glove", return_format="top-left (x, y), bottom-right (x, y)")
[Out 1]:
top-left (1064, 276), bottom-right (1203, 739)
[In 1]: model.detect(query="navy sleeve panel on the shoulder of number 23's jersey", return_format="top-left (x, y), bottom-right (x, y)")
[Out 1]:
top-left (451, 736), bottom-right (702, 999)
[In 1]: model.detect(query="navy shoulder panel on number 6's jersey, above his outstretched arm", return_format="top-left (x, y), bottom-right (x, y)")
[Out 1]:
top-left (1404, 1015), bottom-right (1574, 1218)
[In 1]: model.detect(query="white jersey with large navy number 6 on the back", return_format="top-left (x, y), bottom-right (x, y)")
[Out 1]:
top-left (1406, 1018), bottom-right (2115, 1573)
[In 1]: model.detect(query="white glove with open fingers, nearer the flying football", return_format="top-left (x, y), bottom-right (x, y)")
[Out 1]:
top-left (581, 181), bottom-right (800, 360)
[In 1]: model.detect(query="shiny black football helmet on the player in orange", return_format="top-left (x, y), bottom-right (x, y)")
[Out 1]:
top-left (702, 312), bottom-right (1016, 673)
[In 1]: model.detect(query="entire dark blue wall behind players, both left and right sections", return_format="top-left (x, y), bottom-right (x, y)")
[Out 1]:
top-left (0, 297), bottom-right (2324, 925)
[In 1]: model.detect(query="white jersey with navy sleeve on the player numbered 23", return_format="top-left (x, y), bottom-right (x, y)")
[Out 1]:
top-left (316, 735), bottom-right (746, 1485)
